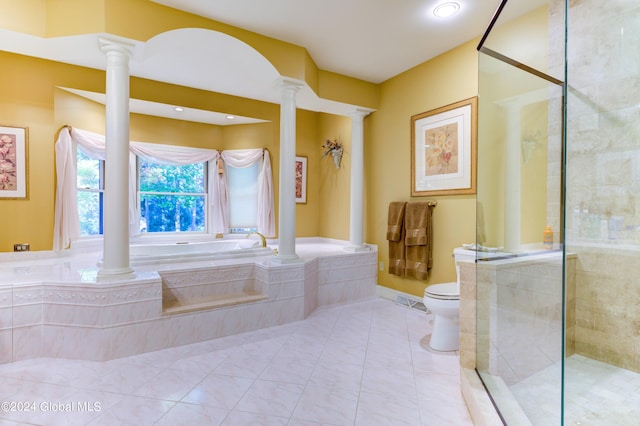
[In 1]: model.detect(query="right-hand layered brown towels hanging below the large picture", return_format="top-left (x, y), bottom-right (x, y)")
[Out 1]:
top-left (405, 203), bottom-right (433, 280)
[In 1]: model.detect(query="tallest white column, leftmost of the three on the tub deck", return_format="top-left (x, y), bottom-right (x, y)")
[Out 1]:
top-left (98, 37), bottom-right (133, 278)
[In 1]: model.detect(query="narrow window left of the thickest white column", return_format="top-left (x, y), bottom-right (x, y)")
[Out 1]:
top-left (76, 148), bottom-right (104, 236)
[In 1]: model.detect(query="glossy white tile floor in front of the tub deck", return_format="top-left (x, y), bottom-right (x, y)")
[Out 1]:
top-left (0, 299), bottom-right (472, 426)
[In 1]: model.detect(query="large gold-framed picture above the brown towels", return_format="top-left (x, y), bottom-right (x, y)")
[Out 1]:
top-left (411, 97), bottom-right (478, 197)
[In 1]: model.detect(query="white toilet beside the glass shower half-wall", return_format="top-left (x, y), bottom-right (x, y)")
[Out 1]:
top-left (423, 248), bottom-right (476, 351)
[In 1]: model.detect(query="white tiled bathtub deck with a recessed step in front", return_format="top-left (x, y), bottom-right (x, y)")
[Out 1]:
top-left (0, 239), bottom-right (378, 364)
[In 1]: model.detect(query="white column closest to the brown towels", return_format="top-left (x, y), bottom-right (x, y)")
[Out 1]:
top-left (345, 108), bottom-right (371, 251)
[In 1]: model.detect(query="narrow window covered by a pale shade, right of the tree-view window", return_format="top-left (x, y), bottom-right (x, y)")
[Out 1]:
top-left (226, 162), bottom-right (261, 233)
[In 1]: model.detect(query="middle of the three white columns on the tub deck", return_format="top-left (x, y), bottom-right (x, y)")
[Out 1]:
top-left (275, 79), bottom-right (302, 263)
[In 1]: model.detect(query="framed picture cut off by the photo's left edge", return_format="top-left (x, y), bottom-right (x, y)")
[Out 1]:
top-left (0, 126), bottom-right (29, 200)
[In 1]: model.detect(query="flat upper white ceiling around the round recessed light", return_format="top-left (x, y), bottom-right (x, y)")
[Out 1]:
top-left (152, 0), bottom-right (547, 83)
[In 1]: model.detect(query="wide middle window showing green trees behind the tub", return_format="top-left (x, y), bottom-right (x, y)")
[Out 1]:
top-left (138, 159), bottom-right (207, 232)
